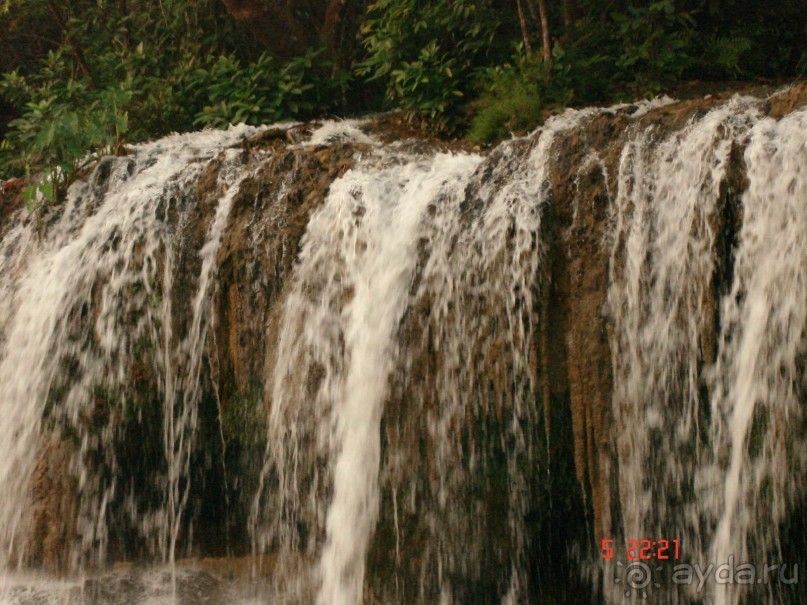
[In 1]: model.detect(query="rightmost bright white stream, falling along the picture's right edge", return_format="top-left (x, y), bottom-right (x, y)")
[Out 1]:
top-left (705, 111), bottom-right (807, 605)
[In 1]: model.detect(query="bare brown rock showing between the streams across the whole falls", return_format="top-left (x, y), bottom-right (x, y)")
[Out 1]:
top-left (7, 81), bottom-right (807, 603)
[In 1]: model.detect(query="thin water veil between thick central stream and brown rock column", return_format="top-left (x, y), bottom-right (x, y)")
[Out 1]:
top-left (385, 110), bottom-right (596, 602)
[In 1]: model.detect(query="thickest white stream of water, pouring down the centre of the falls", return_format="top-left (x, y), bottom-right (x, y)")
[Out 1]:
top-left (256, 143), bottom-right (486, 605)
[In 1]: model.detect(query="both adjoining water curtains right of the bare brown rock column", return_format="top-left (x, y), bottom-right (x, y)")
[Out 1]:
top-left (609, 98), bottom-right (807, 603)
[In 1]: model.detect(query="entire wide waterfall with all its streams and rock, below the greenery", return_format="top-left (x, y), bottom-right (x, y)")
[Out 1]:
top-left (0, 91), bottom-right (807, 605)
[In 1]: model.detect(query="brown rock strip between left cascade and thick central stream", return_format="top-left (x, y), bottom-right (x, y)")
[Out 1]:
top-left (211, 140), bottom-right (361, 554)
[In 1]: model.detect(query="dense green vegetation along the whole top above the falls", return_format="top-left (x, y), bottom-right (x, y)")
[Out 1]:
top-left (0, 0), bottom-right (807, 207)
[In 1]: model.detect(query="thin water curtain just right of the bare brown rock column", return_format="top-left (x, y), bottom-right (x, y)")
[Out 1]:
top-left (608, 99), bottom-right (755, 572)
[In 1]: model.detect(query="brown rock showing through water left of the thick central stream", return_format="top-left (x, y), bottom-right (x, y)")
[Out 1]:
top-left (13, 130), bottom-right (363, 572)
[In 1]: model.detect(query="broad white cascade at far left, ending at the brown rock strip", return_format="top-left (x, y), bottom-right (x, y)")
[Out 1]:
top-left (0, 128), bottom-right (262, 564)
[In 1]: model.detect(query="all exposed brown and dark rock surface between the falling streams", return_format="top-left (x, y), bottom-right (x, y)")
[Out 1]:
top-left (0, 81), bottom-right (807, 603)
